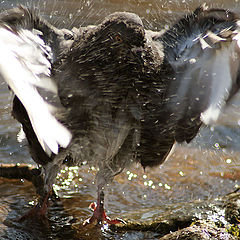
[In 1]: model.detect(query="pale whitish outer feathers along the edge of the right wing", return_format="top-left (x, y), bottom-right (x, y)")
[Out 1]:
top-left (201, 29), bottom-right (240, 125)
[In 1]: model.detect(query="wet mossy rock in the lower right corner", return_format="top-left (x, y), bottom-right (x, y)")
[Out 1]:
top-left (112, 193), bottom-right (240, 240)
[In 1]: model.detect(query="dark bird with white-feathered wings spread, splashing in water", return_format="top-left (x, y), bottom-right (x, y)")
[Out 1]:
top-left (0, 5), bottom-right (240, 224)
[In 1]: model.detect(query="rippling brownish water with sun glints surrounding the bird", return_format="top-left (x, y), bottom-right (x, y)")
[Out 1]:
top-left (0, 0), bottom-right (240, 240)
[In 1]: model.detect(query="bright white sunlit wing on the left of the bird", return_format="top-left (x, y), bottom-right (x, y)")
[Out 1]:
top-left (0, 7), bottom-right (71, 155)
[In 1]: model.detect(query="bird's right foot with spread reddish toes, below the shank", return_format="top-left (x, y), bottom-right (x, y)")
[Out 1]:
top-left (83, 203), bottom-right (125, 226)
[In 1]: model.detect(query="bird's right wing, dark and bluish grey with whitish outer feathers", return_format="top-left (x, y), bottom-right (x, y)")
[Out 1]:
top-left (158, 5), bottom-right (240, 142)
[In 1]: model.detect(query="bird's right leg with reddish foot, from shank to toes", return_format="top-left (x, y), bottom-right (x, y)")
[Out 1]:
top-left (84, 187), bottom-right (125, 225)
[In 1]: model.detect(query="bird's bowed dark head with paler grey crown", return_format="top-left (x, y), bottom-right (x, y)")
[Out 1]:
top-left (79, 12), bottom-right (146, 65)
